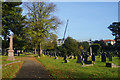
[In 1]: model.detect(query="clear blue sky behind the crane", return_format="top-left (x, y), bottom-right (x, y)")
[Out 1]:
top-left (23, 2), bottom-right (118, 41)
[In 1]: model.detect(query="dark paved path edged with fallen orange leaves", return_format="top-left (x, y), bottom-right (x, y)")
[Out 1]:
top-left (13, 57), bottom-right (50, 79)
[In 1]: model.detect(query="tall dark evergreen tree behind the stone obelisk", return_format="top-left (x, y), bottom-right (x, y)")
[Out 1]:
top-left (2, 2), bottom-right (25, 53)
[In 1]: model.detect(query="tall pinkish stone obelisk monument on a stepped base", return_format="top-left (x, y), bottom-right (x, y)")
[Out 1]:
top-left (7, 35), bottom-right (15, 61)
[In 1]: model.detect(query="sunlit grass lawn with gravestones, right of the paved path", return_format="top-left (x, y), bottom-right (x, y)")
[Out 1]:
top-left (36, 56), bottom-right (120, 78)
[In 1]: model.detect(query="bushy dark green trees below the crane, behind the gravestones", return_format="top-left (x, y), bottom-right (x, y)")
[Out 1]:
top-left (57, 37), bottom-right (89, 57)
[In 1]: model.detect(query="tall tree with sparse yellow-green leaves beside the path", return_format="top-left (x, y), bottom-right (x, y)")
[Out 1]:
top-left (26, 2), bottom-right (60, 56)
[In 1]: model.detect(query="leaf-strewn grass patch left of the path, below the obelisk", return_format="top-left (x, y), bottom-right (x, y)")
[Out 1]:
top-left (2, 56), bottom-right (23, 79)
